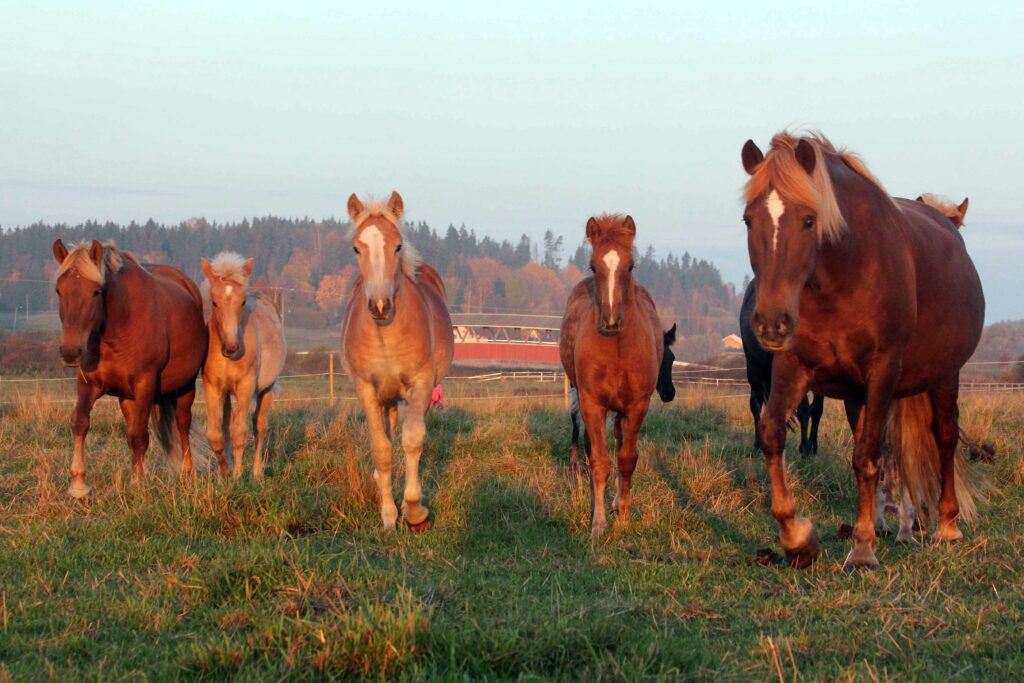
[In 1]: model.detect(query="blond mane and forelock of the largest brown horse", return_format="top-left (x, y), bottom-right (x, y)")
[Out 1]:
top-left (743, 131), bottom-right (892, 243)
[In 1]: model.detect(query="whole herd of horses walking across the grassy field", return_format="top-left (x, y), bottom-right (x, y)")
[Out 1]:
top-left (53, 132), bottom-right (984, 570)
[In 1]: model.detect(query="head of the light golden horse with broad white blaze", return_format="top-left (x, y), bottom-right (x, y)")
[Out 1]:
top-left (348, 193), bottom-right (410, 326)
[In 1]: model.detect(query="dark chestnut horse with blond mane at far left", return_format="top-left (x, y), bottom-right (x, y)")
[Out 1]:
top-left (53, 240), bottom-right (207, 498)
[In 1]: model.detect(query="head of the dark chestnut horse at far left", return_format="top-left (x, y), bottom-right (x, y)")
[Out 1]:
top-left (53, 240), bottom-right (110, 368)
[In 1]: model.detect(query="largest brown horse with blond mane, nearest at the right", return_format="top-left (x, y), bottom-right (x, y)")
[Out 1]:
top-left (741, 132), bottom-right (985, 570)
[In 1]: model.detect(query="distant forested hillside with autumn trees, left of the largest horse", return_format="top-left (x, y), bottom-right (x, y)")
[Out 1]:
top-left (0, 216), bottom-right (738, 346)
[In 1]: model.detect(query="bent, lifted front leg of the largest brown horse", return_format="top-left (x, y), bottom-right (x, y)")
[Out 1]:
top-left (758, 353), bottom-right (818, 568)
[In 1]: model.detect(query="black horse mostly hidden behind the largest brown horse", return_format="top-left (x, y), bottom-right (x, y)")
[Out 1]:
top-left (739, 280), bottom-right (825, 456)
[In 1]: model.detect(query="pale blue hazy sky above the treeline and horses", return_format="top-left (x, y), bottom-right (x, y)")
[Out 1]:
top-left (0, 0), bottom-right (1024, 322)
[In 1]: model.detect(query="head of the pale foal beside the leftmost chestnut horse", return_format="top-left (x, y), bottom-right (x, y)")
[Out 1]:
top-left (202, 252), bottom-right (254, 359)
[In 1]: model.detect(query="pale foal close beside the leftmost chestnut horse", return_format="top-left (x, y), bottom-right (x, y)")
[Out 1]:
top-left (203, 252), bottom-right (287, 479)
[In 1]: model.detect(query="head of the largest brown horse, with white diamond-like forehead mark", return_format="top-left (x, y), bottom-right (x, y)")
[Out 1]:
top-left (742, 133), bottom-right (852, 351)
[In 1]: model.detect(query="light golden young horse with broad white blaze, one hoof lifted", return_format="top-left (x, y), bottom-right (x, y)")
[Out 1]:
top-left (341, 193), bottom-right (455, 531)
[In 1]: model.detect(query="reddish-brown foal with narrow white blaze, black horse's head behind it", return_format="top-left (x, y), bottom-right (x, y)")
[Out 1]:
top-left (558, 215), bottom-right (666, 538)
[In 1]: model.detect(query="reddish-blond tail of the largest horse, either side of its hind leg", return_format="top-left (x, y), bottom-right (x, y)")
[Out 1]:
top-left (890, 393), bottom-right (988, 521)
